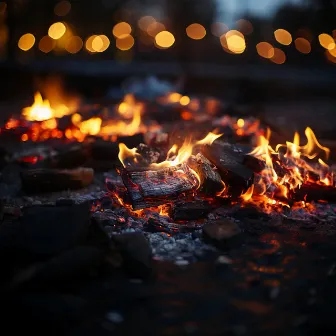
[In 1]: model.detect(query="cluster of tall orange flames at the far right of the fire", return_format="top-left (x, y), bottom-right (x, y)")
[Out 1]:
top-left (243, 127), bottom-right (334, 206)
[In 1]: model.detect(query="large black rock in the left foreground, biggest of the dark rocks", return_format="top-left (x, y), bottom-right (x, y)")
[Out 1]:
top-left (0, 202), bottom-right (90, 256)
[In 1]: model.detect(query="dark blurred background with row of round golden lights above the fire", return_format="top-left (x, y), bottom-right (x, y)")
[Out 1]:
top-left (0, 0), bottom-right (336, 133)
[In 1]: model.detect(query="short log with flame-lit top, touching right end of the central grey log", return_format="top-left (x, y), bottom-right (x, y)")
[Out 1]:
top-left (188, 153), bottom-right (223, 195)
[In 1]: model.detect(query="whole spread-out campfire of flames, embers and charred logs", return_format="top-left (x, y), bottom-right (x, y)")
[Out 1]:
top-left (1, 85), bottom-right (336, 226)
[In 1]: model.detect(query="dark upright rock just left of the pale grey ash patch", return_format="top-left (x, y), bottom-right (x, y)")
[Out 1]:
top-left (112, 232), bottom-right (152, 279)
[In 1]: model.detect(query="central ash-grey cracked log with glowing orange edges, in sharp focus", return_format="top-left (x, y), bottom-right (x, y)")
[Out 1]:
top-left (121, 164), bottom-right (198, 210)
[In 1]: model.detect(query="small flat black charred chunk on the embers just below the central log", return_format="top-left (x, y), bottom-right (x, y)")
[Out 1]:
top-left (171, 200), bottom-right (212, 221)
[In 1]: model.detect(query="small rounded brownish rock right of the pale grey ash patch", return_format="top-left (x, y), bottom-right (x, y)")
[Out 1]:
top-left (203, 219), bottom-right (241, 244)
